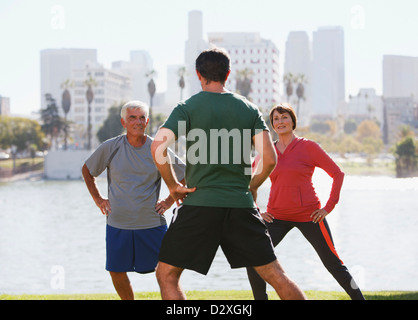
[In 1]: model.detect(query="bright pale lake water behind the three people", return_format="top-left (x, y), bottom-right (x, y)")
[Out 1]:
top-left (0, 170), bottom-right (418, 294)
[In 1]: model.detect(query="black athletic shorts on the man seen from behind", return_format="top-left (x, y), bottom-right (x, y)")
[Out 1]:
top-left (159, 205), bottom-right (276, 275)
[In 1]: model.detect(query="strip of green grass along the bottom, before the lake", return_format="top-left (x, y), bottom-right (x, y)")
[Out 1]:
top-left (0, 290), bottom-right (418, 300)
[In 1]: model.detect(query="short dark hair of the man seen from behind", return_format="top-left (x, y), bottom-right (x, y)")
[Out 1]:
top-left (196, 48), bottom-right (231, 84)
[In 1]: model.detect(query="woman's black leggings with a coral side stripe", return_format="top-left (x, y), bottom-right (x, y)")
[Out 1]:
top-left (247, 219), bottom-right (364, 300)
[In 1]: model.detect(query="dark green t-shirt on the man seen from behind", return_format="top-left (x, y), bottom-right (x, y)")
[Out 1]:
top-left (163, 91), bottom-right (268, 208)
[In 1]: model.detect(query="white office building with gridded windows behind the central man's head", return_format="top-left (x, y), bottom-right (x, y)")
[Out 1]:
top-left (208, 32), bottom-right (281, 112)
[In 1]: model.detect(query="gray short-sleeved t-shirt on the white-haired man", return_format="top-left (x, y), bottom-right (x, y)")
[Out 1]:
top-left (86, 135), bottom-right (185, 230)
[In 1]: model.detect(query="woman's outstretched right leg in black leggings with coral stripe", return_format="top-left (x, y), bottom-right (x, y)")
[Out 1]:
top-left (296, 219), bottom-right (364, 300)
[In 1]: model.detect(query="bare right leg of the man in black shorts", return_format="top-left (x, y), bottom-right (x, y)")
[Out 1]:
top-left (254, 260), bottom-right (307, 300)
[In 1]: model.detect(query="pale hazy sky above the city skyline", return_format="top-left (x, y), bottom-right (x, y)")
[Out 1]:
top-left (0, 0), bottom-right (418, 114)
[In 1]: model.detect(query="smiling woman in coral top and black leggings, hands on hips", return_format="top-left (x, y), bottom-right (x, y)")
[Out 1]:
top-left (247, 105), bottom-right (364, 300)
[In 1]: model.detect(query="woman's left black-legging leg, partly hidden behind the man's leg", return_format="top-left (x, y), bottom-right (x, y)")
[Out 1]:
top-left (247, 219), bottom-right (293, 300)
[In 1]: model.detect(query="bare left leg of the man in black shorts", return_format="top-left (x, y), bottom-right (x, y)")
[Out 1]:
top-left (156, 261), bottom-right (186, 300)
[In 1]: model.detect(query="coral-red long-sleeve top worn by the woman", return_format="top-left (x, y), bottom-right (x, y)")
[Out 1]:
top-left (267, 137), bottom-right (344, 222)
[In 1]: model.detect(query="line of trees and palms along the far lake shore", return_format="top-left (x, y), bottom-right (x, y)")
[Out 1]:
top-left (0, 67), bottom-right (418, 177)
